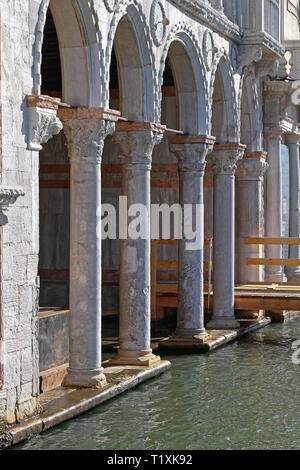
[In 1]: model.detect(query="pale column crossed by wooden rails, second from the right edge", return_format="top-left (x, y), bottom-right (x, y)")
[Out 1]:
top-left (265, 127), bottom-right (286, 282)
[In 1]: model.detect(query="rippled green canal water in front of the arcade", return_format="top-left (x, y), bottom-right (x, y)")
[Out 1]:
top-left (14, 319), bottom-right (300, 450)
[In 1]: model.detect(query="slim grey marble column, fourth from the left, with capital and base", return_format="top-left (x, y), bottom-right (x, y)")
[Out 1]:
top-left (207, 144), bottom-right (245, 330)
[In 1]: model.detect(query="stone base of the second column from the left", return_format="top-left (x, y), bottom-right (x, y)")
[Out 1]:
top-left (103, 350), bottom-right (161, 367)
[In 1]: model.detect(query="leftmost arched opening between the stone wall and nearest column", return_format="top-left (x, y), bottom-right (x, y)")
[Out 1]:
top-left (39, 0), bottom-right (96, 391)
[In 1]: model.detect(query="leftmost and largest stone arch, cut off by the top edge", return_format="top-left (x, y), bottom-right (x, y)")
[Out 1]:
top-left (33, 0), bottom-right (104, 107)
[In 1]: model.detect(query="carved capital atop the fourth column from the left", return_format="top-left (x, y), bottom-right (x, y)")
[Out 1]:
top-left (209, 143), bottom-right (246, 176)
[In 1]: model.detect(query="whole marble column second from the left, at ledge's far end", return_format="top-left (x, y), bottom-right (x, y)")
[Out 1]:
top-left (108, 123), bottom-right (165, 366)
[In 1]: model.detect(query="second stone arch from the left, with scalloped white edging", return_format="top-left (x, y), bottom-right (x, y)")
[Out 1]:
top-left (103, 0), bottom-right (156, 122)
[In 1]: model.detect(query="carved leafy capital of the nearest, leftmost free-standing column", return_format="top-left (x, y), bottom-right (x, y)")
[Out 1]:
top-left (64, 119), bottom-right (115, 165)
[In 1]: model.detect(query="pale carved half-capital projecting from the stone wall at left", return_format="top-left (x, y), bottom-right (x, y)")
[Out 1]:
top-left (28, 107), bottom-right (63, 151)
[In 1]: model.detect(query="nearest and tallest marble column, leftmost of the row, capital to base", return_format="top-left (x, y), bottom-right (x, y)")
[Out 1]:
top-left (60, 108), bottom-right (119, 388)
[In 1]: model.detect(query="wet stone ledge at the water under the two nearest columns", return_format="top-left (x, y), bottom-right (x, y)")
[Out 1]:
top-left (0, 361), bottom-right (171, 449)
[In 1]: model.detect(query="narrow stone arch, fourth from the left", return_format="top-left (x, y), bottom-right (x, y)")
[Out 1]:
top-left (210, 51), bottom-right (239, 143)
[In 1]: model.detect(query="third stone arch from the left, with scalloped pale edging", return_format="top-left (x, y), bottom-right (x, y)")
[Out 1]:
top-left (156, 22), bottom-right (209, 135)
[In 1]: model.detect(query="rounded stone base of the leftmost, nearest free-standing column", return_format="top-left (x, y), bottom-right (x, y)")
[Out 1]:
top-left (62, 368), bottom-right (106, 389)
